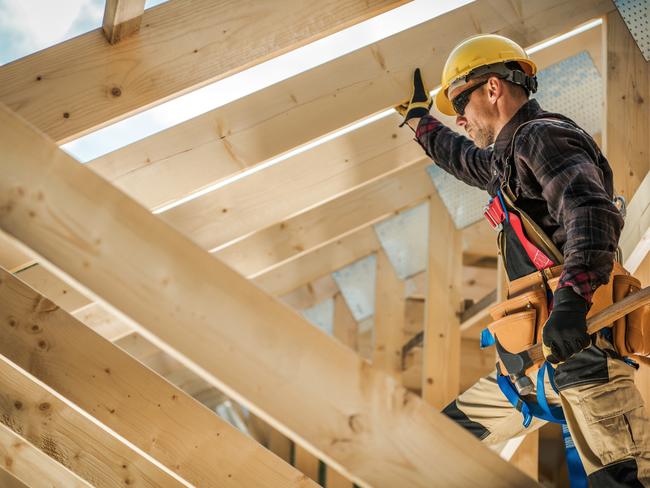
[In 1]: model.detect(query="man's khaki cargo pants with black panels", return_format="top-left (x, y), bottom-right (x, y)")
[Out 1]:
top-left (443, 336), bottom-right (650, 488)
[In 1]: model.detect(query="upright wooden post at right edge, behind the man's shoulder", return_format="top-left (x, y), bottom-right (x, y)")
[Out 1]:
top-left (603, 10), bottom-right (650, 201)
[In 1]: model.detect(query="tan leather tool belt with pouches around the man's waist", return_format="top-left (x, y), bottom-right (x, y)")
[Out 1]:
top-left (488, 262), bottom-right (650, 374)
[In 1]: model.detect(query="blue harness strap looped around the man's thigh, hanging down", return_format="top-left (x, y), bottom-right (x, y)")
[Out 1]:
top-left (497, 361), bottom-right (589, 488)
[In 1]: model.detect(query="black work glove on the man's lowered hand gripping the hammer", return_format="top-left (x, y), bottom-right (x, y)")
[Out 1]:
top-left (542, 286), bottom-right (591, 363)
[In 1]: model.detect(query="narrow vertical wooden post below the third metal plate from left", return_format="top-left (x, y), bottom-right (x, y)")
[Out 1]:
top-left (372, 249), bottom-right (406, 381)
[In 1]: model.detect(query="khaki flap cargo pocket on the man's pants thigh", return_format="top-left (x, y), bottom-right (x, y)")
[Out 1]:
top-left (579, 381), bottom-right (650, 465)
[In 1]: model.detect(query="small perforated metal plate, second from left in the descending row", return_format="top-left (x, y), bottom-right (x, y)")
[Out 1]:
top-left (332, 255), bottom-right (377, 322)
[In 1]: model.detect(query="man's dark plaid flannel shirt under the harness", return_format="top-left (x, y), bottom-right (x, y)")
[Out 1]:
top-left (416, 99), bottom-right (623, 302)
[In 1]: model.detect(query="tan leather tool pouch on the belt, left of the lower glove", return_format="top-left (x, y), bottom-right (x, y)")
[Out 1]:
top-left (488, 287), bottom-right (548, 374)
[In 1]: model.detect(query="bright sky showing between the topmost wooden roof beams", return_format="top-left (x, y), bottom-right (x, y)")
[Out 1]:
top-left (0, 0), bottom-right (472, 162)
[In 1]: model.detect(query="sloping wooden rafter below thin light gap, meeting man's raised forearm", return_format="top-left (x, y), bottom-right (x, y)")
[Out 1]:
top-left (161, 114), bottom-right (422, 249)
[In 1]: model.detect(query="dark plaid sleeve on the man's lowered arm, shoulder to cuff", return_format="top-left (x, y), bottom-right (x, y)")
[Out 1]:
top-left (517, 123), bottom-right (623, 302)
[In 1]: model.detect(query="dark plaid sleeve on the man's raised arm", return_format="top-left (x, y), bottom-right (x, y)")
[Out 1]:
top-left (415, 115), bottom-right (492, 190)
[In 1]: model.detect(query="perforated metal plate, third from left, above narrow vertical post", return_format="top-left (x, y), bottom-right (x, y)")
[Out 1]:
top-left (375, 204), bottom-right (429, 280)
